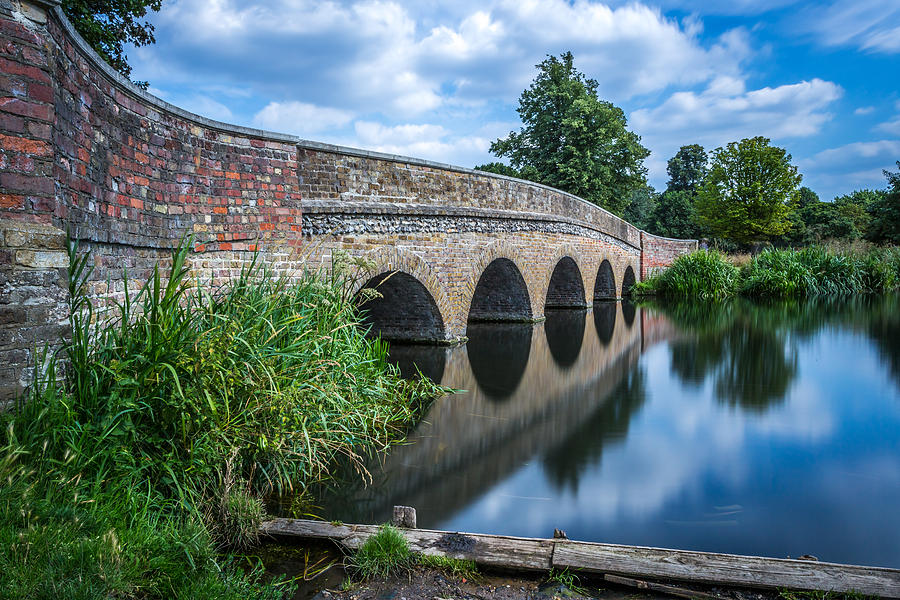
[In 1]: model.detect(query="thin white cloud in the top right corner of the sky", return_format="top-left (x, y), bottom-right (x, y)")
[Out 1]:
top-left (801, 0), bottom-right (900, 54)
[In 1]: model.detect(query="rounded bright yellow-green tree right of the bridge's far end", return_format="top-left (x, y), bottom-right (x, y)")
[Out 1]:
top-left (696, 137), bottom-right (803, 244)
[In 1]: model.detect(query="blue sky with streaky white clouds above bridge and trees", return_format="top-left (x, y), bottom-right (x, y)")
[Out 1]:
top-left (129, 0), bottom-right (900, 200)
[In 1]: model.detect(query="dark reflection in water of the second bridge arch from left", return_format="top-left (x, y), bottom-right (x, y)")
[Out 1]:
top-left (465, 323), bottom-right (534, 400)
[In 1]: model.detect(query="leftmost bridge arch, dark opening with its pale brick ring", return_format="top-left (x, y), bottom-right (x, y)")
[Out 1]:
top-left (353, 247), bottom-right (453, 341)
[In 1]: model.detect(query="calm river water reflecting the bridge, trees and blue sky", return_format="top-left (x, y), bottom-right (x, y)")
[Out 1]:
top-left (316, 299), bottom-right (900, 567)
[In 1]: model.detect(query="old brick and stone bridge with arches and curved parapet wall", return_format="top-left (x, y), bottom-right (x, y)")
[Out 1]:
top-left (0, 0), bottom-right (696, 400)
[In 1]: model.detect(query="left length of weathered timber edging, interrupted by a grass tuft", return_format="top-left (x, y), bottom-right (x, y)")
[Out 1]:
top-left (261, 519), bottom-right (553, 571)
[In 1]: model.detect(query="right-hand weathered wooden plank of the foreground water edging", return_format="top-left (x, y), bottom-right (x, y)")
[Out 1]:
top-left (553, 540), bottom-right (900, 598)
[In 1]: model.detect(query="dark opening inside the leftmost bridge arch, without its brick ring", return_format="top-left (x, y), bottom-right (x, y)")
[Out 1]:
top-left (357, 271), bottom-right (444, 340)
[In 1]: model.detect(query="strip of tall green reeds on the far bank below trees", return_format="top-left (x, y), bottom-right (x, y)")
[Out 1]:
top-left (633, 247), bottom-right (900, 299)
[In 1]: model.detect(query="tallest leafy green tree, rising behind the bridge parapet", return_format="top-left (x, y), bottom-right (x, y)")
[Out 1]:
top-left (491, 52), bottom-right (650, 214)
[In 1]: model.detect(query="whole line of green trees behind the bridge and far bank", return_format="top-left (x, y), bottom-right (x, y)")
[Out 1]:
top-left (475, 52), bottom-right (900, 250)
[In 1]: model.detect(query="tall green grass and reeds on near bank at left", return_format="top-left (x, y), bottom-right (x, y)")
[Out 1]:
top-left (0, 242), bottom-right (443, 600)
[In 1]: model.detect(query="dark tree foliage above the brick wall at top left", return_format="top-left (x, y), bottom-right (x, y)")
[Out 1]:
top-left (62, 0), bottom-right (162, 80)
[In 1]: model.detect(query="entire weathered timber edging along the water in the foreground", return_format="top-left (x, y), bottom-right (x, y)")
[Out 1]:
top-left (261, 519), bottom-right (900, 598)
